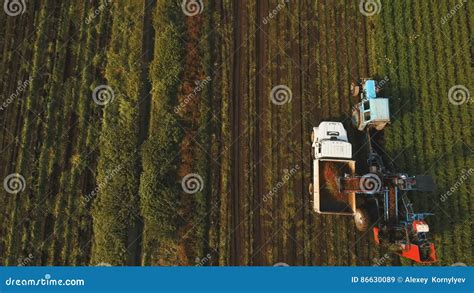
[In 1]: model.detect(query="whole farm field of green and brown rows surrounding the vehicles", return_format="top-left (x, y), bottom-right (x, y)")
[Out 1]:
top-left (0, 0), bottom-right (474, 266)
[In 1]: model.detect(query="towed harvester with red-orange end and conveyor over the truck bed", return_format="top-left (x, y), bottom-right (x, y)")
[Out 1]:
top-left (339, 144), bottom-right (436, 263)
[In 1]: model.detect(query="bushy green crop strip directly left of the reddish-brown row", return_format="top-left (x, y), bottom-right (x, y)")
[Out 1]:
top-left (140, 2), bottom-right (184, 265)
